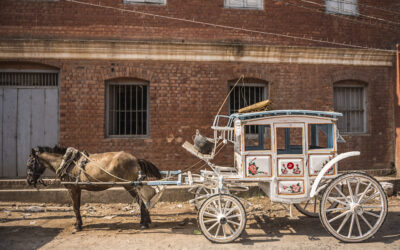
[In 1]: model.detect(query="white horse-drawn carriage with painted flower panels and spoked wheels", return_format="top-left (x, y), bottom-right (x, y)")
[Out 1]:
top-left (183, 110), bottom-right (388, 243)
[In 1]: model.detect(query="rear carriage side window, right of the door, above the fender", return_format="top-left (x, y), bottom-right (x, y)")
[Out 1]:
top-left (308, 124), bottom-right (333, 149)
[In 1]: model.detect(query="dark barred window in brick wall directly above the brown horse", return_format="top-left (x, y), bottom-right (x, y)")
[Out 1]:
top-left (106, 81), bottom-right (149, 137)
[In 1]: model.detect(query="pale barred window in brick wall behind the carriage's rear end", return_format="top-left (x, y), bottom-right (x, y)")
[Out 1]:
top-left (333, 85), bottom-right (366, 133)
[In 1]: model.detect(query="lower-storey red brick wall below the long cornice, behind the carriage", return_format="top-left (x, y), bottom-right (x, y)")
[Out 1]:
top-left (3, 60), bottom-right (394, 172)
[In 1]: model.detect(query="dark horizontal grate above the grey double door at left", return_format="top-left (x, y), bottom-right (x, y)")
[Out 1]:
top-left (0, 72), bottom-right (58, 87)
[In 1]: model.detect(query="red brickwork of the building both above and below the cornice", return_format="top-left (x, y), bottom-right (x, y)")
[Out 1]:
top-left (0, 0), bottom-right (400, 173)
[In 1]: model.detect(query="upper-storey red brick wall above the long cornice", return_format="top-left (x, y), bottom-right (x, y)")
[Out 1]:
top-left (0, 0), bottom-right (400, 49)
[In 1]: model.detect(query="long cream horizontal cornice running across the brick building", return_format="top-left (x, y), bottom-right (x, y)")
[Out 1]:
top-left (0, 40), bottom-right (395, 67)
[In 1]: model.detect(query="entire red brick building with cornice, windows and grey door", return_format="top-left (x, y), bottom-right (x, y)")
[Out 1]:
top-left (0, 0), bottom-right (400, 177)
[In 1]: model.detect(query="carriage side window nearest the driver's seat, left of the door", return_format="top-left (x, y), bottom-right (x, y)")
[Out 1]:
top-left (244, 125), bottom-right (271, 150)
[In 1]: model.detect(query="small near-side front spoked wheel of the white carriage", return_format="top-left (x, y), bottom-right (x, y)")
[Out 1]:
top-left (198, 194), bottom-right (246, 243)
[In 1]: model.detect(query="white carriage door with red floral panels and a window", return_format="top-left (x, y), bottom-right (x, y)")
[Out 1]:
top-left (275, 123), bottom-right (306, 196)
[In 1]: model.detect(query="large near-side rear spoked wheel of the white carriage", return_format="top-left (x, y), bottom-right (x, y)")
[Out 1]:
top-left (320, 173), bottom-right (388, 242)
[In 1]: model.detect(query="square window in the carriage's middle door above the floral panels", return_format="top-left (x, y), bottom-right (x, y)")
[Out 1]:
top-left (276, 128), bottom-right (303, 154)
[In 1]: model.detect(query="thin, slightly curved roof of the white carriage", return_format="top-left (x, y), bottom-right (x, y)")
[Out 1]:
top-left (229, 110), bottom-right (343, 120)
